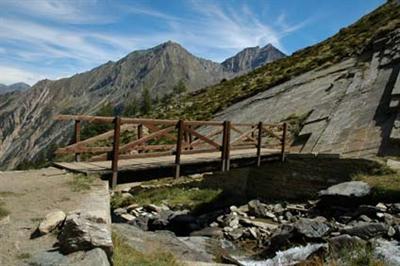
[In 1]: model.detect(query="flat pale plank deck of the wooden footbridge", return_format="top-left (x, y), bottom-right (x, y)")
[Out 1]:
top-left (54, 149), bottom-right (280, 174)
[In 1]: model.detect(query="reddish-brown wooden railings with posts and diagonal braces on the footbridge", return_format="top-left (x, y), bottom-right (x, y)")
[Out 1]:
top-left (55, 115), bottom-right (287, 186)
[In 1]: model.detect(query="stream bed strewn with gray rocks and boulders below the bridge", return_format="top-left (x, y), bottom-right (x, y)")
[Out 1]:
top-left (112, 181), bottom-right (400, 265)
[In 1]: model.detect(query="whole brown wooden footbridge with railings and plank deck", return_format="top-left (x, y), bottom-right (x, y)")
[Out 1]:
top-left (54, 115), bottom-right (287, 187)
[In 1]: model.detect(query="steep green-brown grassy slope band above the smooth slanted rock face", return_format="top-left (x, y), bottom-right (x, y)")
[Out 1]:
top-left (151, 0), bottom-right (400, 119)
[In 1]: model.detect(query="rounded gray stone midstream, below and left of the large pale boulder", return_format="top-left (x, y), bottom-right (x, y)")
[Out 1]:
top-left (293, 218), bottom-right (330, 238)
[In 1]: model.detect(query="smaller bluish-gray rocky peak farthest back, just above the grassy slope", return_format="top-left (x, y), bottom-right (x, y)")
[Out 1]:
top-left (222, 44), bottom-right (286, 73)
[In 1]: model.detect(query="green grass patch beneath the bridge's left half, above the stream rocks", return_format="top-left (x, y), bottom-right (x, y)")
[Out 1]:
top-left (111, 186), bottom-right (222, 210)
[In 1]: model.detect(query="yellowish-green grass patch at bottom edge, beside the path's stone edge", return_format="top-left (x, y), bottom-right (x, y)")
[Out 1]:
top-left (112, 232), bottom-right (181, 266)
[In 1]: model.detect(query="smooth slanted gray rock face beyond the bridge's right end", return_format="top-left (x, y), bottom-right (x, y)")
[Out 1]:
top-left (215, 29), bottom-right (400, 157)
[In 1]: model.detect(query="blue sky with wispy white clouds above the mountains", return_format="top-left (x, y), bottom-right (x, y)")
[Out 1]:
top-left (0, 0), bottom-right (385, 84)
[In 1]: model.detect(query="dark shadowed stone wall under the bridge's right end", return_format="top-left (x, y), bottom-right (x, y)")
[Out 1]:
top-left (205, 155), bottom-right (380, 202)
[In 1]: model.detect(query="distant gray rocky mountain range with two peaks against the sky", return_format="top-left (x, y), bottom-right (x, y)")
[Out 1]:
top-left (0, 41), bottom-right (285, 168)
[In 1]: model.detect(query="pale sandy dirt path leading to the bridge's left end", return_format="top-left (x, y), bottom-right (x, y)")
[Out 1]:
top-left (0, 168), bottom-right (102, 266)
